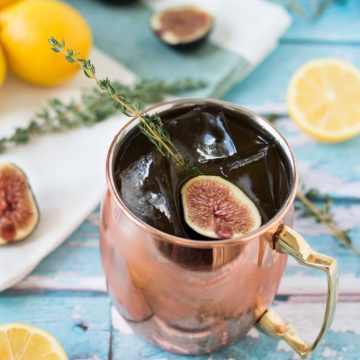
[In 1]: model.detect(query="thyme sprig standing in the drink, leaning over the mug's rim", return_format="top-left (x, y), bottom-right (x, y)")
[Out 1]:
top-left (49, 37), bottom-right (188, 169)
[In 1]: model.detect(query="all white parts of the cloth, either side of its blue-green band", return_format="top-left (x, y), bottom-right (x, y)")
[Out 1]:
top-left (0, 0), bottom-right (290, 290)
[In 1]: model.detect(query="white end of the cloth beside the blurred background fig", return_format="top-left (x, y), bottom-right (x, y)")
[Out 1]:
top-left (147, 0), bottom-right (291, 70)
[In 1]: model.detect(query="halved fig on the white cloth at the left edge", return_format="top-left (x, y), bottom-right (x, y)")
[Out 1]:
top-left (0, 163), bottom-right (39, 245)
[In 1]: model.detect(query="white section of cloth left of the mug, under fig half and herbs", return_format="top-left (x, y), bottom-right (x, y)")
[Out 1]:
top-left (0, 50), bottom-right (135, 290)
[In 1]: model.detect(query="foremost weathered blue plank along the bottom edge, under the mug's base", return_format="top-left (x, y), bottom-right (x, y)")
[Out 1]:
top-left (0, 292), bottom-right (360, 360)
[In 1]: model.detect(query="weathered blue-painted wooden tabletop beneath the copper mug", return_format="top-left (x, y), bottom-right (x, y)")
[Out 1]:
top-left (0, 0), bottom-right (360, 360)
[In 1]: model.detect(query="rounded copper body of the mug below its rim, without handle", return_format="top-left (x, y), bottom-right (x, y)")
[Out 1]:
top-left (101, 187), bottom-right (287, 354)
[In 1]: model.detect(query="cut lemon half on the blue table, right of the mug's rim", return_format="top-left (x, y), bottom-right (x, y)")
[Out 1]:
top-left (287, 59), bottom-right (360, 143)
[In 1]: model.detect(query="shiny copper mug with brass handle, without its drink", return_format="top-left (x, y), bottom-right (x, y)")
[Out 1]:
top-left (100, 99), bottom-right (338, 356)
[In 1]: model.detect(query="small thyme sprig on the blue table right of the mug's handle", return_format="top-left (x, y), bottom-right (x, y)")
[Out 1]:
top-left (296, 189), bottom-right (360, 256)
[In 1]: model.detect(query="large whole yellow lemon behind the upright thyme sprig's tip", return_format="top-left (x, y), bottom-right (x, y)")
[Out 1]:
top-left (0, 0), bottom-right (92, 85)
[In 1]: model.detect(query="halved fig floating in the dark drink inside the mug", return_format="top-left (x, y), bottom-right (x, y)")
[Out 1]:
top-left (181, 175), bottom-right (261, 239)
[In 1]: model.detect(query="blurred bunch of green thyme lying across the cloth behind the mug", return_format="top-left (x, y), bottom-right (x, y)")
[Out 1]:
top-left (0, 79), bottom-right (205, 153)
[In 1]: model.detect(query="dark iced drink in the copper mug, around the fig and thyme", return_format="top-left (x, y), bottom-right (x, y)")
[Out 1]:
top-left (114, 104), bottom-right (290, 240)
